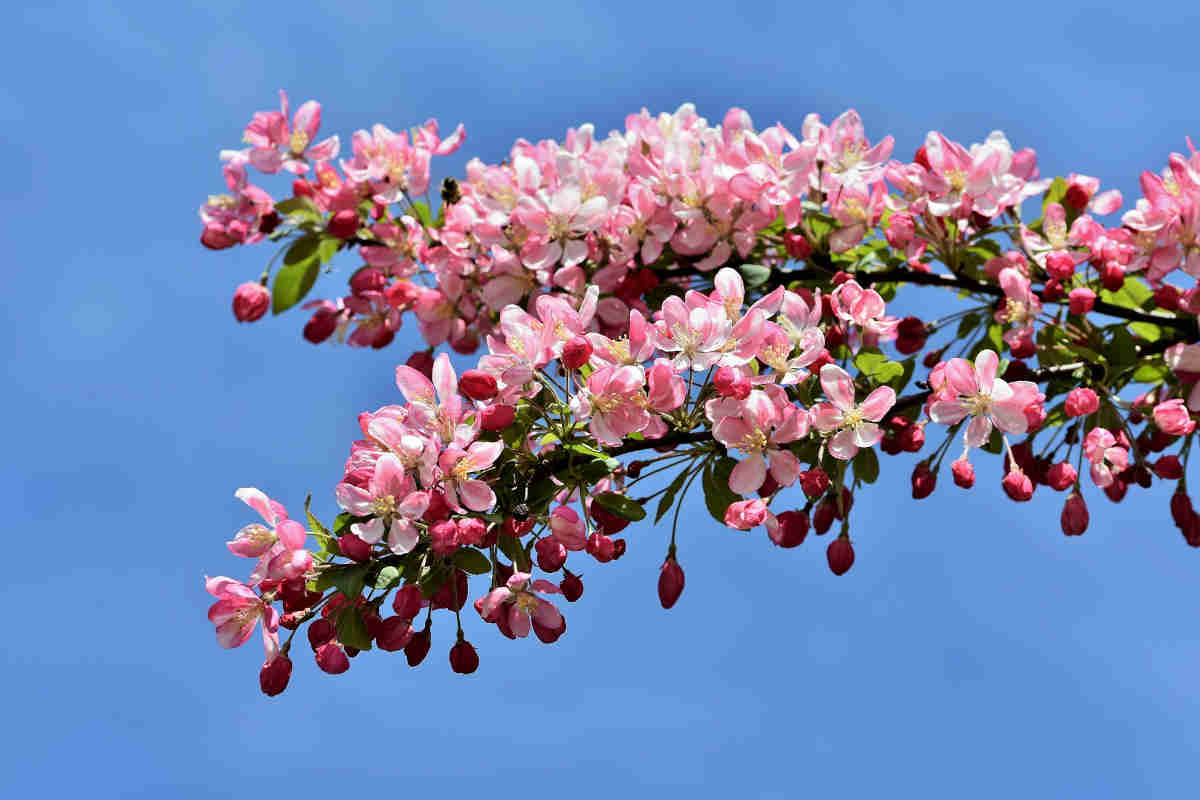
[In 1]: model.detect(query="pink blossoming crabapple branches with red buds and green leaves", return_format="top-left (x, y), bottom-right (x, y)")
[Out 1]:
top-left (200, 95), bottom-right (1200, 694)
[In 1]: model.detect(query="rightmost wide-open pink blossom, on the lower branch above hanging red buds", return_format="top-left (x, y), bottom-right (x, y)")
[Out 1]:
top-left (929, 350), bottom-right (1037, 447)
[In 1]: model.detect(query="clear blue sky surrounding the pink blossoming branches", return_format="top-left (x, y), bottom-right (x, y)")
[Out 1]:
top-left (0, 0), bottom-right (1200, 799)
